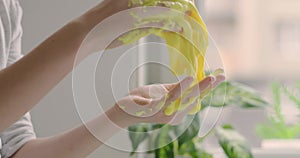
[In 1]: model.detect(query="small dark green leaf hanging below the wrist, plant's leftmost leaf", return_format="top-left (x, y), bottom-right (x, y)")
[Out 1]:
top-left (128, 124), bottom-right (152, 156)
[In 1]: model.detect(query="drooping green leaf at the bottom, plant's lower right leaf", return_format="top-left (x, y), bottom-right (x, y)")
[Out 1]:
top-left (215, 125), bottom-right (253, 158)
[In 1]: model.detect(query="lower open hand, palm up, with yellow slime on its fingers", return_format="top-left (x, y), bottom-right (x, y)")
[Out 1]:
top-left (108, 71), bottom-right (225, 126)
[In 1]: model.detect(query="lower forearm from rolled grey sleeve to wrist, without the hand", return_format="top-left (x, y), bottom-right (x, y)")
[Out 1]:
top-left (13, 108), bottom-right (129, 158)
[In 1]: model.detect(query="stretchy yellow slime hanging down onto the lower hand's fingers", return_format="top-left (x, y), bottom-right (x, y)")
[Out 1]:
top-left (119, 0), bottom-right (208, 116)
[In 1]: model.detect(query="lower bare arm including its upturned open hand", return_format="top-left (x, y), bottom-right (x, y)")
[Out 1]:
top-left (13, 76), bottom-right (224, 158)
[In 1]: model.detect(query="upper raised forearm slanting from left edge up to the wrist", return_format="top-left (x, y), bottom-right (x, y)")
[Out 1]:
top-left (0, 1), bottom-right (115, 131)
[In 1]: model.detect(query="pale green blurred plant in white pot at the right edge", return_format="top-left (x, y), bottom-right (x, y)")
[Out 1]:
top-left (256, 82), bottom-right (300, 148)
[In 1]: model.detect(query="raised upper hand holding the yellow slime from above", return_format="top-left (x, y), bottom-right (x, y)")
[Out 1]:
top-left (74, 0), bottom-right (148, 53)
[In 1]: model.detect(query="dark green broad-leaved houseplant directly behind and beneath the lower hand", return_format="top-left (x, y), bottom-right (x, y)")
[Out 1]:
top-left (129, 82), bottom-right (267, 158)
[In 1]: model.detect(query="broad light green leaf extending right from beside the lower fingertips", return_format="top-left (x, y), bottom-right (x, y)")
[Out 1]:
top-left (202, 82), bottom-right (268, 109)
